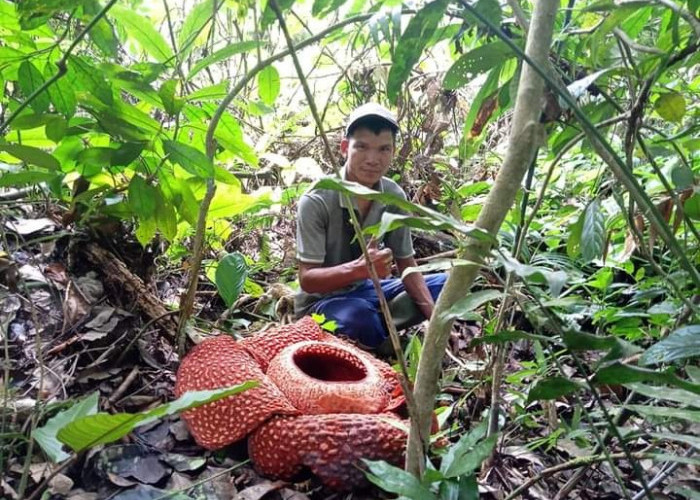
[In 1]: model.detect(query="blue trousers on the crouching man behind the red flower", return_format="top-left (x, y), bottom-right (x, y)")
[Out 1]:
top-left (312, 273), bottom-right (447, 348)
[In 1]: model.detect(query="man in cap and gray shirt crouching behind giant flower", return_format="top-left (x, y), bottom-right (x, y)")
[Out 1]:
top-left (295, 103), bottom-right (446, 348)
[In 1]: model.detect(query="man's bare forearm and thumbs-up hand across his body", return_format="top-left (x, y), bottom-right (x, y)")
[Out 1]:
top-left (299, 248), bottom-right (394, 296)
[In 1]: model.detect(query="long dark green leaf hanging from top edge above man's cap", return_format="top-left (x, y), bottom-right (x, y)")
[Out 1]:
top-left (386, 0), bottom-right (449, 104)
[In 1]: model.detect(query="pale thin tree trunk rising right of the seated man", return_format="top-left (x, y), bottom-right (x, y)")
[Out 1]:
top-left (407, 0), bottom-right (559, 475)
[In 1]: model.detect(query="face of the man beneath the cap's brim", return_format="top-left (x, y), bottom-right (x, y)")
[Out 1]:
top-left (340, 128), bottom-right (394, 187)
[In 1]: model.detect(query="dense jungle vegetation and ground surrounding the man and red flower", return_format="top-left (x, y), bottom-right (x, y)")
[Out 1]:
top-left (0, 0), bottom-right (700, 500)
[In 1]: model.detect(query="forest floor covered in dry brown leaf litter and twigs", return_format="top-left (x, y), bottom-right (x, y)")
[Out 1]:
top-left (0, 195), bottom-right (698, 500)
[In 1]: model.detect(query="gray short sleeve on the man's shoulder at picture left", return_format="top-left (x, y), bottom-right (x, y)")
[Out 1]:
top-left (297, 193), bottom-right (328, 264)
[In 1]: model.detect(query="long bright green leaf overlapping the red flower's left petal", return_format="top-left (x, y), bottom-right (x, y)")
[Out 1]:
top-left (58, 381), bottom-right (258, 452)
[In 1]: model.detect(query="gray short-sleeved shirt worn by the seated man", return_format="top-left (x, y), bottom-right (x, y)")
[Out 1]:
top-left (294, 170), bottom-right (413, 317)
